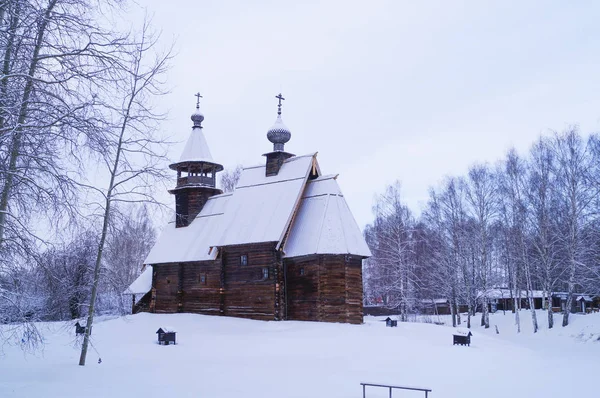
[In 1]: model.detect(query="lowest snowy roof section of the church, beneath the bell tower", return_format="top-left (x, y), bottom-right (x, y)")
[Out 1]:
top-left (144, 193), bottom-right (232, 264)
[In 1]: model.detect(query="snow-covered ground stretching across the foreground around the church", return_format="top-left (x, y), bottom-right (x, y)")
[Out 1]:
top-left (0, 311), bottom-right (600, 398)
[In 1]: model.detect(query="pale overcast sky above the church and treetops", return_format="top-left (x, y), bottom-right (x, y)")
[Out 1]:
top-left (132, 0), bottom-right (600, 227)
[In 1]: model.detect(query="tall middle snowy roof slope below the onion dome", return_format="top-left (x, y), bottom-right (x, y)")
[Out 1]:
top-left (212, 154), bottom-right (316, 246)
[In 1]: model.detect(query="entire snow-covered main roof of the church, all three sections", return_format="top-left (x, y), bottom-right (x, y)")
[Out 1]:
top-left (145, 153), bottom-right (371, 264)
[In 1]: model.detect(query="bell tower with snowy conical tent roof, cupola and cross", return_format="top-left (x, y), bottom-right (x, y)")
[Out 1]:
top-left (169, 93), bottom-right (223, 228)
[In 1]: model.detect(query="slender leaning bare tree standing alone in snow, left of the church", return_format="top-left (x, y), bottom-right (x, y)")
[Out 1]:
top-left (79, 21), bottom-right (171, 366)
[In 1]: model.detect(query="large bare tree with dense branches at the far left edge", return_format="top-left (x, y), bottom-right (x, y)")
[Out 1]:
top-left (0, 0), bottom-right (131, 348)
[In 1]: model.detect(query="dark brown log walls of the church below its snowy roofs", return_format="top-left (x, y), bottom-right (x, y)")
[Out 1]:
top-left (149, 250), bottom-right (363, 324)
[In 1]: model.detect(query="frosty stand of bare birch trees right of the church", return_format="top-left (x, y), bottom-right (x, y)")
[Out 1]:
top-left (363, 127), bottom-right (600, 329)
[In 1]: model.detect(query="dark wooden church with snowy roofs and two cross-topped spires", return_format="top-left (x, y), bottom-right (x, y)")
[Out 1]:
top-left (127, 94), bottom-right (371, 324)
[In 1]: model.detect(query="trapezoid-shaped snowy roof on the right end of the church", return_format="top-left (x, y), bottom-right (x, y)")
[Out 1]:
top-left (283, 176), bottom-right (371, 257)
